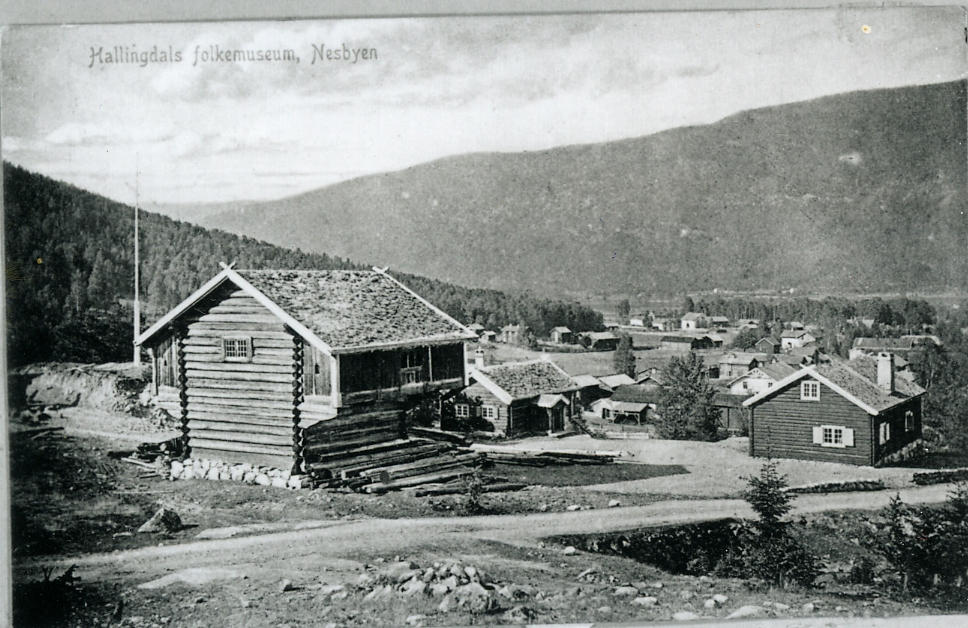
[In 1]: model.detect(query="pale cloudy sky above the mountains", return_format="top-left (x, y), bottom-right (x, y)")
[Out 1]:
top-left (0, 7), bottom-right (968, 204)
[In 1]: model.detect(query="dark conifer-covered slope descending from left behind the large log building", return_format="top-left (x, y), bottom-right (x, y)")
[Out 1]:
top-left (3, 163), bottom-right (602, 366)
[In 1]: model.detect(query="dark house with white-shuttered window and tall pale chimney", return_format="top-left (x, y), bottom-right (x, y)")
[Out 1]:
top-left (743, 353), bottom-right (924, 465)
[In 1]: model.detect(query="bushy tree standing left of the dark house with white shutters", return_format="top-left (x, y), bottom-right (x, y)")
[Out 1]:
top-left (656, 351), bottom-right (719, 441)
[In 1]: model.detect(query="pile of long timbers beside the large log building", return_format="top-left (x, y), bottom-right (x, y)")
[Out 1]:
top-left (305, 438), bottom-right (486, 493)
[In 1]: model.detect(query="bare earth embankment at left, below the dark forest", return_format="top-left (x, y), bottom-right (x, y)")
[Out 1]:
top-left (9, 363), bottom-right (151, 414)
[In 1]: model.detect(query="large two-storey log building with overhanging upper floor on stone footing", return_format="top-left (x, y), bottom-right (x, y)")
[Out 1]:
top-left (135, 264), bottom-right (476, 472)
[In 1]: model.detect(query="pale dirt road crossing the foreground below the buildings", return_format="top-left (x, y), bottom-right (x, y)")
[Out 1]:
top-left (17, 485), bottom-right (950, 585)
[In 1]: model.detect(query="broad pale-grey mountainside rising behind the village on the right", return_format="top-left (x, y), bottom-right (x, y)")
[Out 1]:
top-left (201, 81), bottom-right (968, 295)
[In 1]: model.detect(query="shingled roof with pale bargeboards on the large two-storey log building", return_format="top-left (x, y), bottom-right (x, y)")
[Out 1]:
top-left (138, 268), bottom-right (474, 352)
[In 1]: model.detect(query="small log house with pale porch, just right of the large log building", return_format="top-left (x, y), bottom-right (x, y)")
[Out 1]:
top-left (457, 359), bottom-right (579, 436)
